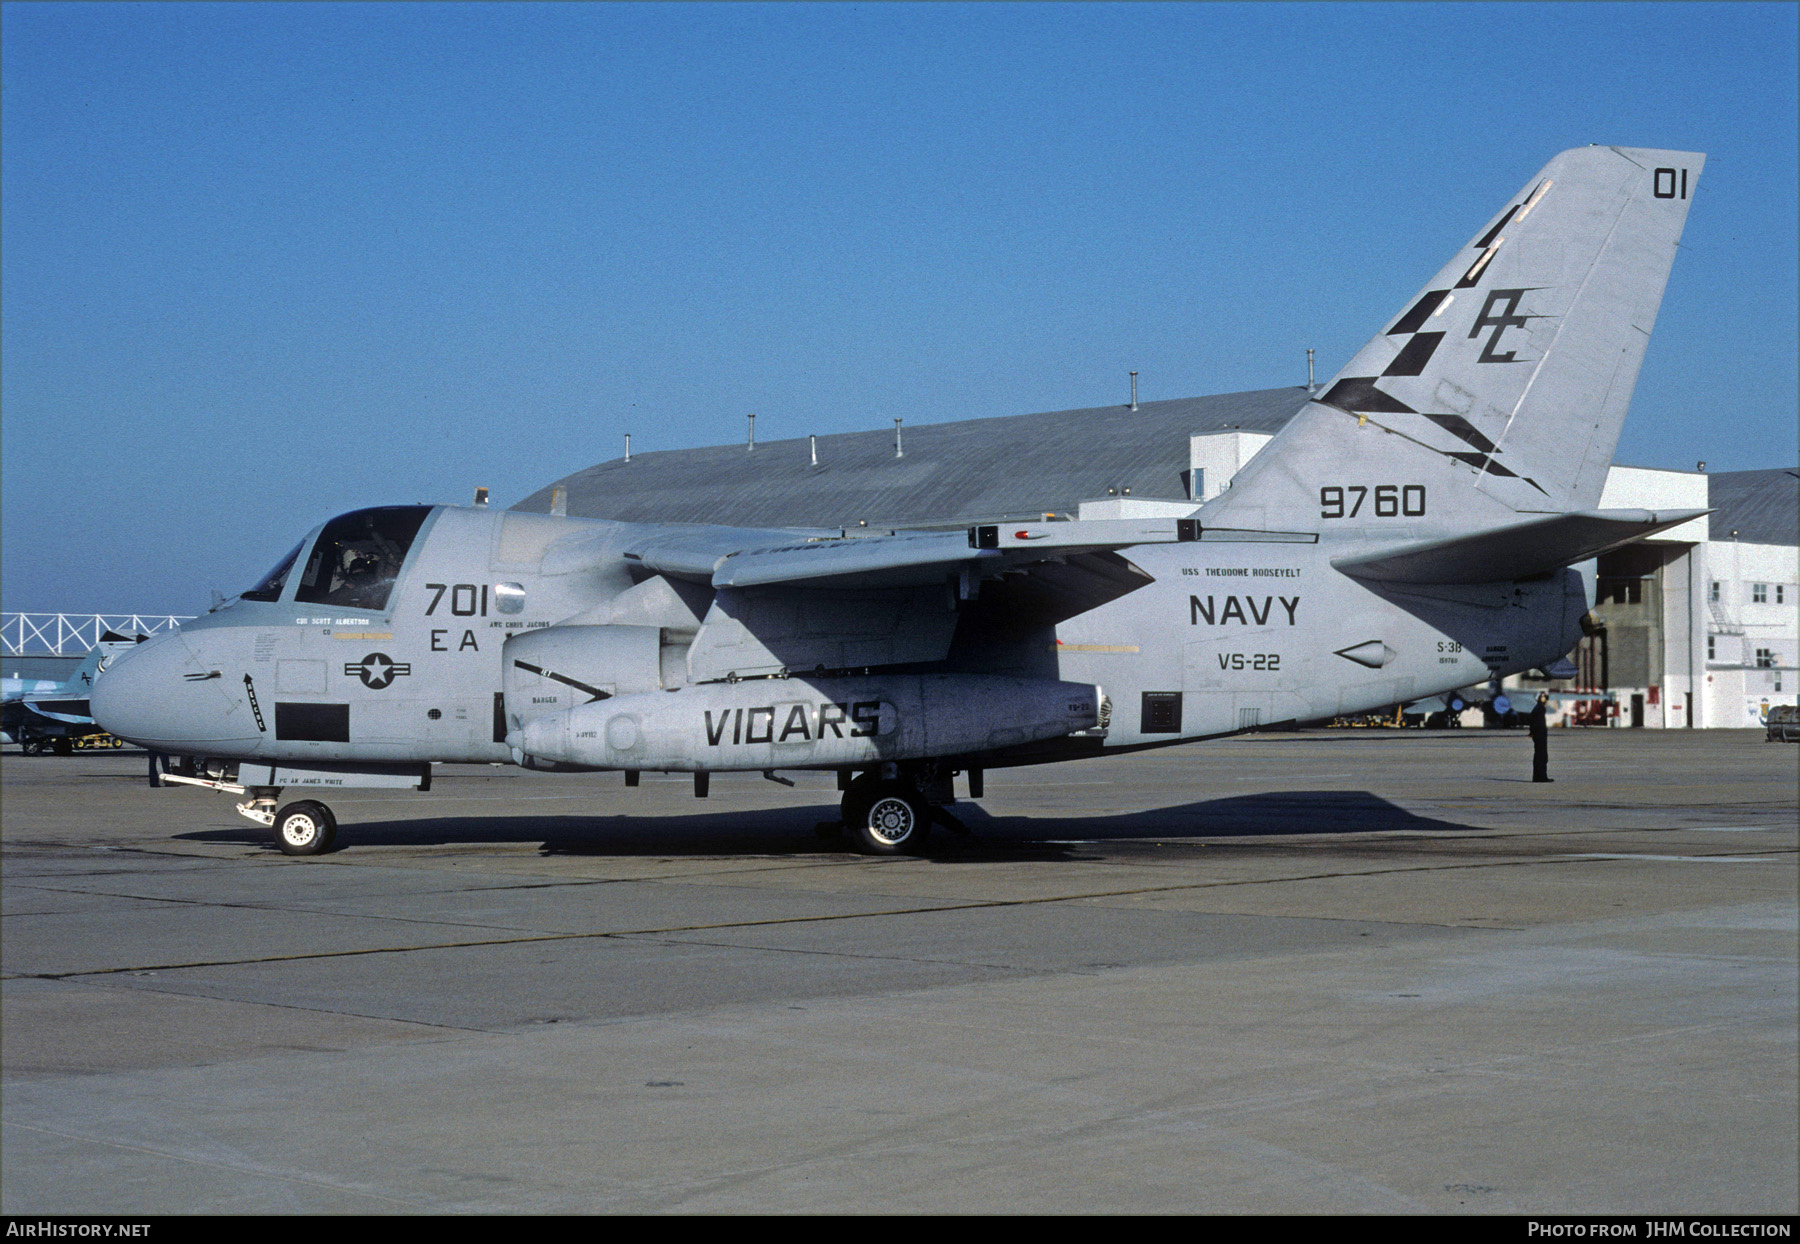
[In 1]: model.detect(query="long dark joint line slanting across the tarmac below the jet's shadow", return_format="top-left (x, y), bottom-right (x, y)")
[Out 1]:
top-left (0, 848), bottom-right (1800, 981)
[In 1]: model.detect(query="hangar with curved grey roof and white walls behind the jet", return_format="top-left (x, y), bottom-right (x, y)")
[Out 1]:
top-left (515, 385), bottom-right (1800, 727)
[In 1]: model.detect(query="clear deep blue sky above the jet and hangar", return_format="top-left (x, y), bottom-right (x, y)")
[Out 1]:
top-left (0, 4), bottom-right (1800, 614)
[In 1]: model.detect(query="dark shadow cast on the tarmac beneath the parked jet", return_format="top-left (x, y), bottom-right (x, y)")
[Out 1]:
top-left (176, 790), bottom-right (1474, 859)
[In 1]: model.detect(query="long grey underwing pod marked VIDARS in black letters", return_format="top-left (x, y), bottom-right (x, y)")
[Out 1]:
top-left (506, 673), bottom-right (1100, 771)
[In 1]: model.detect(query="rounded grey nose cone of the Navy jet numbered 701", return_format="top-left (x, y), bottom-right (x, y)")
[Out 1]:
top-left (88, 634), bottom-right (259, 753)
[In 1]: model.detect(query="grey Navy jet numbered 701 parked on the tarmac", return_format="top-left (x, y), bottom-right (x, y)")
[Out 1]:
top-left (92, 146), bottom-right (1705, 855)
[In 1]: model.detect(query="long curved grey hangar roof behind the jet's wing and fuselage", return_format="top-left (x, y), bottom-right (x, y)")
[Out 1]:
top-left (515, 385), bottom-right (1309, 527)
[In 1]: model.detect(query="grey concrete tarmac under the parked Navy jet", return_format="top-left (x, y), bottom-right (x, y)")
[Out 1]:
top-left (0, 729), bottom-right (1800, 1215)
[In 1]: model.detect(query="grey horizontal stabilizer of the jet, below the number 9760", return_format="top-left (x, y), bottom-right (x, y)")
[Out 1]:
top-left (1332, 509), bottom-right (1712, 583)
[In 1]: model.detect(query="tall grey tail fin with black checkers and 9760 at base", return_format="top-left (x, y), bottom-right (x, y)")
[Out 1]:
top-left (1206, 146), bottom-right (1705, 529)
